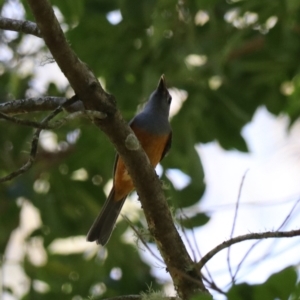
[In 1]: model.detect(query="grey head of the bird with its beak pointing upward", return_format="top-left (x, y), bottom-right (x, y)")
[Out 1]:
top-left (143, 75), bottom-right (172, 116)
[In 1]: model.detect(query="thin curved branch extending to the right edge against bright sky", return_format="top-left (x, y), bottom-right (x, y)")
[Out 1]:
top-left (197, 229), bottom-right (300, 270)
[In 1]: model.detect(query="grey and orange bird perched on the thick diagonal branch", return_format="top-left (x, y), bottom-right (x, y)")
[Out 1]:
top-left (87, 75), bottom-right (172, 246)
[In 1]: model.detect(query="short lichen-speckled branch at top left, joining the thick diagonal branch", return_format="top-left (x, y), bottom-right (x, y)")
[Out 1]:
top-left (0, 17), bottom-right (41, 37)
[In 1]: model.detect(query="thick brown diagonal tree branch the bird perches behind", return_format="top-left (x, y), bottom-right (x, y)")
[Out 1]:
top-left (27, 0), bottom-right (206, 299)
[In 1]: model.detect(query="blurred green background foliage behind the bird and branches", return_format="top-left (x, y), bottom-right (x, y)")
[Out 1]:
top-left (0, 0), bottom-right (300, 300)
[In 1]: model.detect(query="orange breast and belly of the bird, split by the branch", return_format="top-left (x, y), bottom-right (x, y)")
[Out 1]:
top-left (114, 125), bottom-right (169, 201)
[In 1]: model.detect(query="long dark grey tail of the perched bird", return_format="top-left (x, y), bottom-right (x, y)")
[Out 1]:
top-left (87, 187), bottom-right (127, 246)
